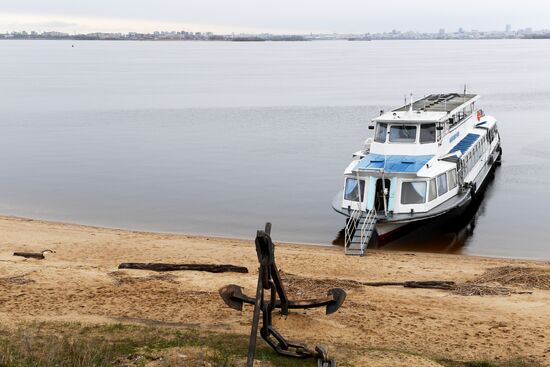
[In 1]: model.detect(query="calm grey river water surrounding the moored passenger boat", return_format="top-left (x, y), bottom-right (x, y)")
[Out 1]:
top-left (0, 40), bottom-right (550, 259)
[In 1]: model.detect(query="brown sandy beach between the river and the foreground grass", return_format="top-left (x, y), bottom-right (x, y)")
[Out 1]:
top-left (0, 217), bottom-right (550, 366)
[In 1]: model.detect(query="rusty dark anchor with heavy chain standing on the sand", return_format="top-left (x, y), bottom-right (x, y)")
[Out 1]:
top-left (219, 223), bottom-right (346, 367)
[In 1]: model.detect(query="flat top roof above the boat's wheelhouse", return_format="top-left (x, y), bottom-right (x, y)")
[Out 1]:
top-left (373, 93), bottom-right (479, 122)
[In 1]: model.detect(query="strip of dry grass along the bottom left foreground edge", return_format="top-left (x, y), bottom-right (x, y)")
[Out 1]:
top-left (0, 322), bottom-right (315, 367)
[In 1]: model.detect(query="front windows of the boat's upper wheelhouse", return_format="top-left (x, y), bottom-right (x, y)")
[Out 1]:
top-left (374, 122), bottom-right (436, 144)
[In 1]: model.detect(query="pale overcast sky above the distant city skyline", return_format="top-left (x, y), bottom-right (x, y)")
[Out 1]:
top-left (0, 0), bottom-right (550, 33)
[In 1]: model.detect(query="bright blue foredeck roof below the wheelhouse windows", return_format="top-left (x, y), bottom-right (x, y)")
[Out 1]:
top-left (354, 154), bottom-right (433, 173)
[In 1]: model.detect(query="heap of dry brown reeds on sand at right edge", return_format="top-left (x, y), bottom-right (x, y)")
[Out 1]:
top-left (475, 266), bottom-right (550, 290)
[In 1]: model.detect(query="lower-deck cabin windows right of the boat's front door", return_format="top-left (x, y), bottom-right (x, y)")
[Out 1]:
top-left (401, 169), bottom-right (458, 205)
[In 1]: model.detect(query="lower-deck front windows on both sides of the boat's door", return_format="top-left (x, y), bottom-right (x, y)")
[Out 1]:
top-left (344, 169), bottom-right (458, 204)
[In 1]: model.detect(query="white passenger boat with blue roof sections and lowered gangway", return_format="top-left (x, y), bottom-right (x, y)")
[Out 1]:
top-left (332, 93), bottom-right (502, 255)
